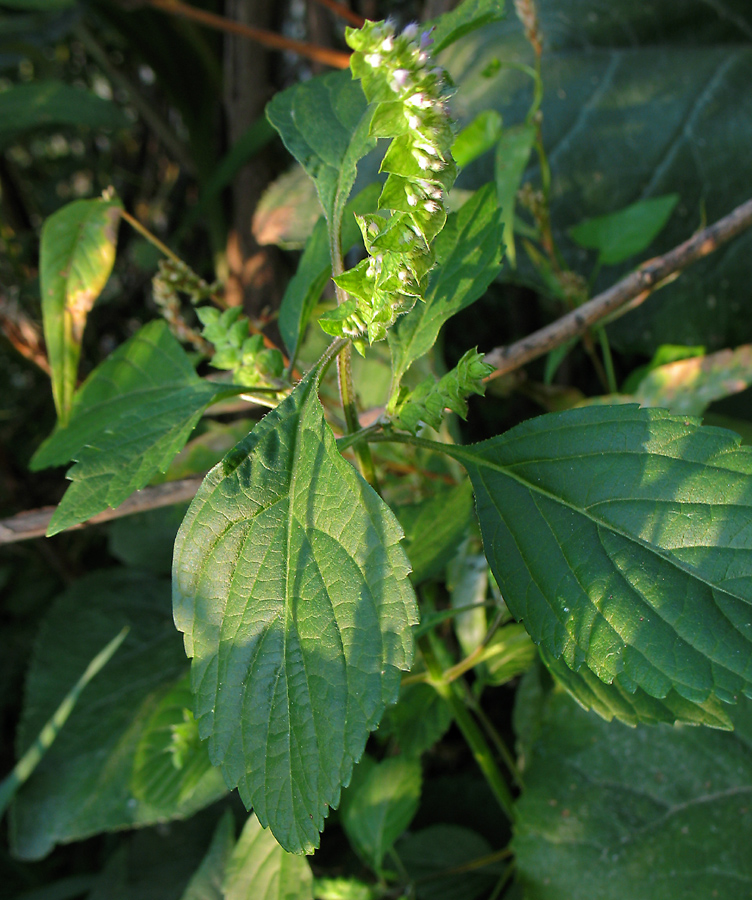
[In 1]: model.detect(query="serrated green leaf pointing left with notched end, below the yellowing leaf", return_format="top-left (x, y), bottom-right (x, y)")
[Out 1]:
top-left (32, 321), bottom-right (244, 534)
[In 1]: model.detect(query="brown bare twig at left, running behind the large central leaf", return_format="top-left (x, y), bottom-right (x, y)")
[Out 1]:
top-left (0, 478), bottom-right (201, 544)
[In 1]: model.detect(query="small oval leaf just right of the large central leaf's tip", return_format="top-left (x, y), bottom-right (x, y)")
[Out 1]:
top-left (341, 756), bottom-right (422, 872)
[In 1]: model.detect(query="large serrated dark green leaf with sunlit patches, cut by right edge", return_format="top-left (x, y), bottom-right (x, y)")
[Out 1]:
top-left (451, 406), bottom-right (752, 703)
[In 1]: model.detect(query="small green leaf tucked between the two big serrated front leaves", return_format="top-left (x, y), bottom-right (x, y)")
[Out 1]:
top-left (397, 481), bottom-right (473, 584)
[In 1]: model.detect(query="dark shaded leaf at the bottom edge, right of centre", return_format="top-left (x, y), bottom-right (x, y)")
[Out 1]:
top-left (397, 825), bottom-right (498, 900)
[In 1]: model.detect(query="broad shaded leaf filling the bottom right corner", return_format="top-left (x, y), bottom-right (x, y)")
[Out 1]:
top-left (512, 693), bottom-right (752, 900)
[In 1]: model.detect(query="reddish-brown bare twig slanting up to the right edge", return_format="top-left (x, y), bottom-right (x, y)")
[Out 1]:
top-left (485, 200), bottom-right (752, 380)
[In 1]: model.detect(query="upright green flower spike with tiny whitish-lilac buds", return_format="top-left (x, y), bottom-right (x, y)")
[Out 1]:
top-left (321, 21), bottom-right (457, 342)
